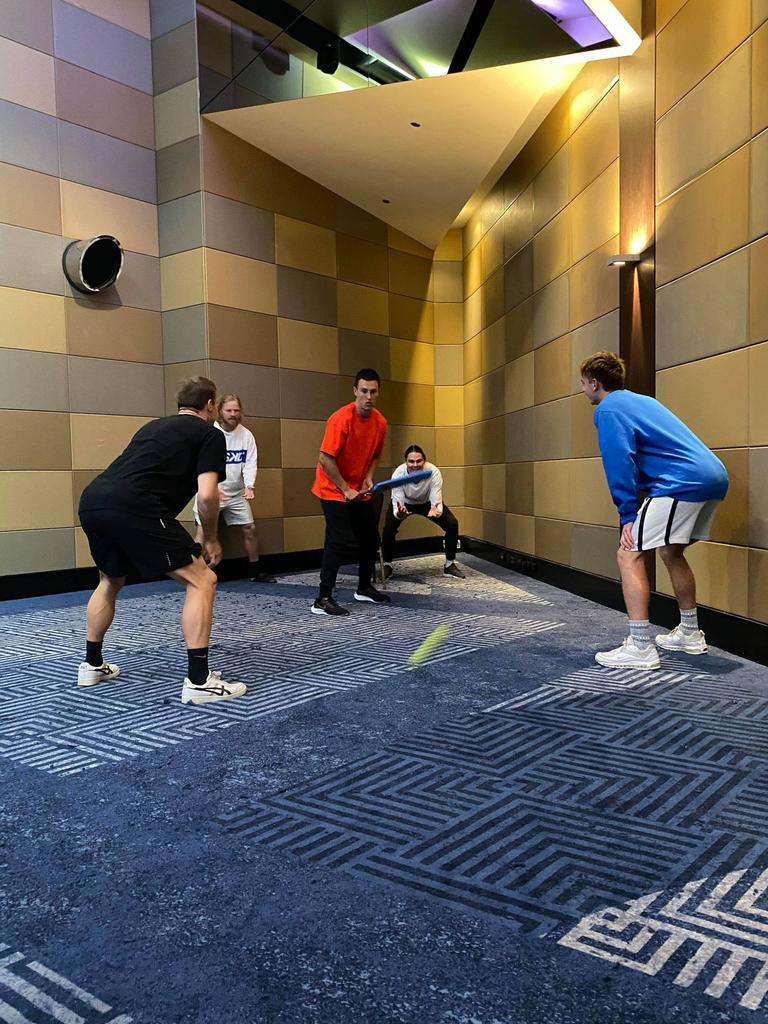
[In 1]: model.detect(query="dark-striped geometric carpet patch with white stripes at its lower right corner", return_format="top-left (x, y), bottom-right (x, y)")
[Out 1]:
top-left (219, 658), bottom-right (768, 1010)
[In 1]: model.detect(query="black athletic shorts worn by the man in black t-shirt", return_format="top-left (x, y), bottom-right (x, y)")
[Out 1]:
top-left (80, 509), bottom-right (201, 580)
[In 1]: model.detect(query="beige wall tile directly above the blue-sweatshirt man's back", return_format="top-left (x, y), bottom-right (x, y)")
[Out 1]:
top-left (656, 349), bottom-right (755, 447)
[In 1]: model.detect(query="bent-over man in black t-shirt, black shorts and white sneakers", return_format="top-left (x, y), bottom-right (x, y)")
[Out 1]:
top-left (78, 377), bottom-right (246, 705)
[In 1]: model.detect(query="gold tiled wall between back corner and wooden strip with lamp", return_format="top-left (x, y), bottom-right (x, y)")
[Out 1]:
top-left (457, 60), bottom-right (620, 577)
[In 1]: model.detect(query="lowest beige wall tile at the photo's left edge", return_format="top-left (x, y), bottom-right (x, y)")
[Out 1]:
top-left (0, 470), bottom-right (75, 530)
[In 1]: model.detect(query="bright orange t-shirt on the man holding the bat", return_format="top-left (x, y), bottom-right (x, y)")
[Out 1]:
top-left (312, 401), bottom-right (387, 502)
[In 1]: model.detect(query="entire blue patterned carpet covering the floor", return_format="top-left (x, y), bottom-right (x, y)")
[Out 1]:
top-left (0, 556), bottom-right (768, 1024)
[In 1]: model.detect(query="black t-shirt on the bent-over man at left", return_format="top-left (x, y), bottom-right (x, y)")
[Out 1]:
top-left (80, 416), bottom-right (226, 518)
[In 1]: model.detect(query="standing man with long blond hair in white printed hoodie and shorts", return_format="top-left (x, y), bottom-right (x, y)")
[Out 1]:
top-left (195, 394), bottom-right (274, 583)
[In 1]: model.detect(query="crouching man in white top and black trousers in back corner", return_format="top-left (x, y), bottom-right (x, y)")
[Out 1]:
top-left (381, 444), bottom-right (465, 580)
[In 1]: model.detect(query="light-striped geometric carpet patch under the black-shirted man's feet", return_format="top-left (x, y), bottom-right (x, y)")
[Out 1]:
top-left (0, 559), bottom-right (560, 774)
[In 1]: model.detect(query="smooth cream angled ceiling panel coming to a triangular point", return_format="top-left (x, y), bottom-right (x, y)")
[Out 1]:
top-left (204, 0), bottom-right (639, 248)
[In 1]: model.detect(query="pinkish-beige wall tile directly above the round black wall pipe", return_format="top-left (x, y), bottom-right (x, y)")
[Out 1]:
top-left (61, 180), bottom-right (160, 256)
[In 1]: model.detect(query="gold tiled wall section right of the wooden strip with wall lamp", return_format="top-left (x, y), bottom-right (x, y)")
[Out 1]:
top-left (656, 0), bottom-right (768, 622)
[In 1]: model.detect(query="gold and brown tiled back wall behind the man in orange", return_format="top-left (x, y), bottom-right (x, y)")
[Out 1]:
top-left (180, 119), bottom-right (464, 555)
